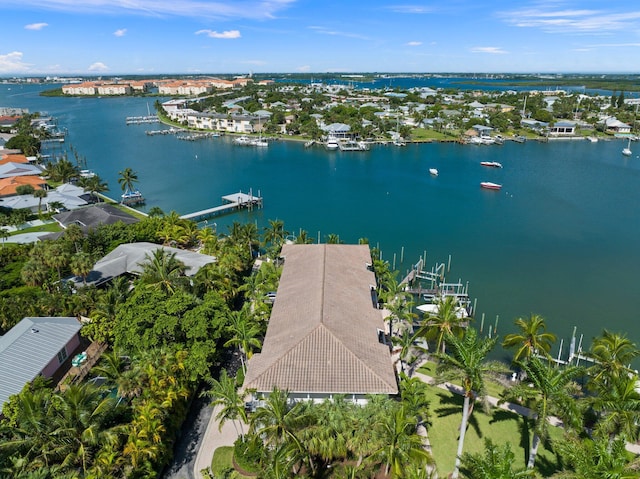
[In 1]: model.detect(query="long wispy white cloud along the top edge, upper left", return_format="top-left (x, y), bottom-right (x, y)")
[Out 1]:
top-left (2, 0), bottom-right (297, 20)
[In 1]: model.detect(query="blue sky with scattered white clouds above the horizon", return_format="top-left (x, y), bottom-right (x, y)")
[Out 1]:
top-left (0, 0), bottom-right (640, 76)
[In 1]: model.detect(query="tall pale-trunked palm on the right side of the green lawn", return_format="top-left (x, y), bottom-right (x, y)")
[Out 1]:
top-left (503, 356), bottom-right (582, 469)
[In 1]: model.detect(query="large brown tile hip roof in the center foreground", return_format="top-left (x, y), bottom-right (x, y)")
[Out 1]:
top-left (244, 244), bottom-right (397, 394)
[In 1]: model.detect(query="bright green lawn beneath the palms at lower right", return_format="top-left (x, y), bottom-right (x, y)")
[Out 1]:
top-left (428, 387), bottom-right (562, 477)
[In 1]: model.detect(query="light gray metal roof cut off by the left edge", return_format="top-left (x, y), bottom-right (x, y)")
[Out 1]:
top-left (0, 317), bottom-right (82, 408)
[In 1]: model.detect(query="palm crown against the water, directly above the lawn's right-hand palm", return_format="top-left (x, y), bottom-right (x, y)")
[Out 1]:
top-left (502, 314), bottom-right (556, 362)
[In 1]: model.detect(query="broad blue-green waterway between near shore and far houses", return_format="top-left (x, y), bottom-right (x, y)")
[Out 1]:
top-left (0, 85), bottom-right (640, 358)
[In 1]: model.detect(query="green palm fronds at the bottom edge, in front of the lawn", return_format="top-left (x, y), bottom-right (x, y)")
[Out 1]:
top-left (460, 439), bottom-right (534, 479)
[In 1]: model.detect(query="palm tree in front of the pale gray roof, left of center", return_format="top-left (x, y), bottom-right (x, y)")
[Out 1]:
top-left (140, 248), bottom-right (189, 295)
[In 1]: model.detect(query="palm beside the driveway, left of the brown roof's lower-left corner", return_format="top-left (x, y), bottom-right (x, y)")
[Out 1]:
top-left (201, 369), bottom-right (247, 436)
